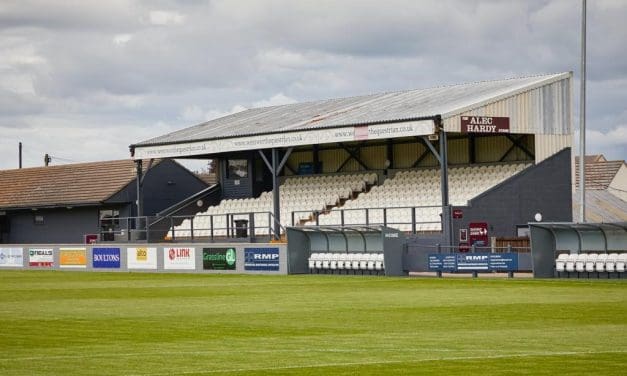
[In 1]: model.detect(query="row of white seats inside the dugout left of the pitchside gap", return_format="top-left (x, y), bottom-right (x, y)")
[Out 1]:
top-left (308, 252), bottom-right (385, 274)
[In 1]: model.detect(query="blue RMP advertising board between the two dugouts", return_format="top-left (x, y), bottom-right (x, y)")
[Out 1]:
top-left (429, 253), bottom-right (518, 272)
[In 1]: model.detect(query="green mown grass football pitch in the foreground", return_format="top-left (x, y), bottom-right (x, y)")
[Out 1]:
top-left (0, 270), bottom-right (627, 376)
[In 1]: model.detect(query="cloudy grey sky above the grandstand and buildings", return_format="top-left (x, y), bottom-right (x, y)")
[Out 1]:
top-left (0, 0), bottom-right (627, 169)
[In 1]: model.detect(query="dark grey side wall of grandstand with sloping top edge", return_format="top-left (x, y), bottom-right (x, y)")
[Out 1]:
top-left (452, 148), bottom-right (572, 245)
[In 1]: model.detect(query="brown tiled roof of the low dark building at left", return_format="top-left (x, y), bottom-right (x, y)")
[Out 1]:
top-left (0, 159), bottom-right (159, 209)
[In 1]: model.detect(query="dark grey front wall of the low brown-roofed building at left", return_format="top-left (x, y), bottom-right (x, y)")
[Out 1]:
top-left (5, 207), bottom-right (124, 244)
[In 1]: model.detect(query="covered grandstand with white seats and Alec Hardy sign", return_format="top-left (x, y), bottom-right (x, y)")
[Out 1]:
top-left (131, 73), bottom-right (572, 250)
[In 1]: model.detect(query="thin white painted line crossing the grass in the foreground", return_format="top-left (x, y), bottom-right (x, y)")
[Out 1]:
top-left (126, 350), bottom-right (627, 376)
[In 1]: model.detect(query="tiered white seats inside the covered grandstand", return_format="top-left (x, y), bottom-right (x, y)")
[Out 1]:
top-left (167, 162), bottom-right (530, 239)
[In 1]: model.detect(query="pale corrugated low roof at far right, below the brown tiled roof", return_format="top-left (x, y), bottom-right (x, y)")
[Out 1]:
top-left (573, 190), bottom-right (627, 222)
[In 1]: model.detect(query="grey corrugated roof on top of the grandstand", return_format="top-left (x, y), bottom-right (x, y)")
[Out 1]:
top-left (134, 73), bottom-right (571, 147)
